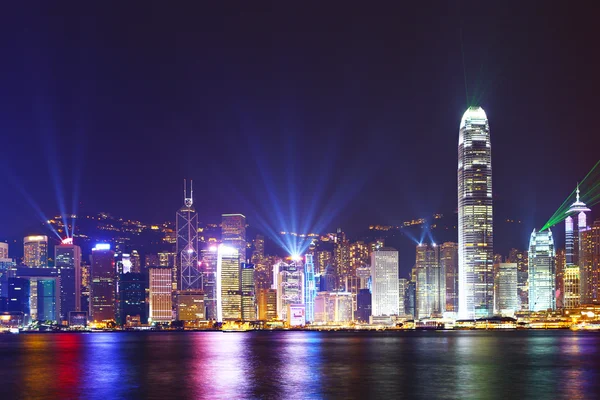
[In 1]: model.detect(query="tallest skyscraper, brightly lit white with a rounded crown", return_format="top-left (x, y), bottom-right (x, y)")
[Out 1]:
top-left (458, 107), bottom-right (494, 319)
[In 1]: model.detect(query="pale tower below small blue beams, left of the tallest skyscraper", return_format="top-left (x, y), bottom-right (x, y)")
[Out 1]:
top-left (416, 243), bottom-right (446, 319)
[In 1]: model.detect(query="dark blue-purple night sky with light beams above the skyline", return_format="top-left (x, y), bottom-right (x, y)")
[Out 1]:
top-left (0, 2), bottom-right (600, 247)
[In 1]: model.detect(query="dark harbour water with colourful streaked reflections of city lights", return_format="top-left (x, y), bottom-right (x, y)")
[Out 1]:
top-left (0, 331), bottom-right (600, 399)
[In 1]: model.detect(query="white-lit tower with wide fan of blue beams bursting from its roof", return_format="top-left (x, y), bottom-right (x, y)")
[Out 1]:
top-left (273, 260), bottom-right (304, 321)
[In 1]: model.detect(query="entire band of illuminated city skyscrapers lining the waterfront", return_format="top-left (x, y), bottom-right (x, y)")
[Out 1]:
top-left (0, 107), bottom-right (600, 329)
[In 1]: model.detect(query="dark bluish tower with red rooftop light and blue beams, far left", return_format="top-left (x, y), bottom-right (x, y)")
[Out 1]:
top-left (54, 241), bottom-right (81, 322)
